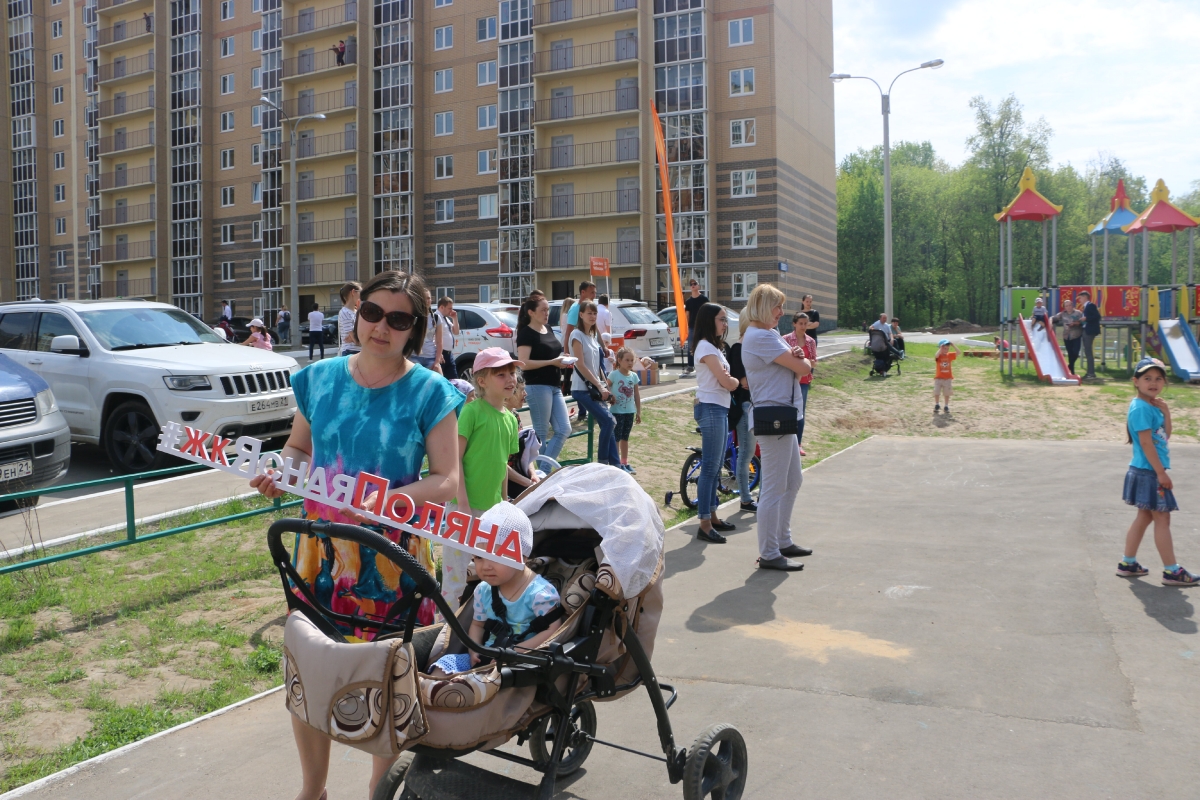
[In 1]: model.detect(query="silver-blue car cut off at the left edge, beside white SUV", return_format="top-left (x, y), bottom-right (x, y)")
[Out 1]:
top-left (0, 354), bottom-right (71, 511)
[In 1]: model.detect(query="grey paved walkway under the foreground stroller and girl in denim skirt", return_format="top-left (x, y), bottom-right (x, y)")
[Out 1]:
top-left (11, 438), bottom-right (1200, 800)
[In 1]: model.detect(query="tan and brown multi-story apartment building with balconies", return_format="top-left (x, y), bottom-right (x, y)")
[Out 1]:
top-left (0, 0), bottom-right (836, 321)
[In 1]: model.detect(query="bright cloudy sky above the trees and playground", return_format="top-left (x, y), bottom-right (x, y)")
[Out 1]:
top-left (833, 0), bottom-right (1200, 194)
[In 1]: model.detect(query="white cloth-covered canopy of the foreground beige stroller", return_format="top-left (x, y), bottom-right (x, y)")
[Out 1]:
top-left (516, 464), bottom-right (666, 597)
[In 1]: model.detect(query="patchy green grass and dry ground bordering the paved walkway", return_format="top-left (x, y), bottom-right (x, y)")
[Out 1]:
top-left (0, 344), bottom-right (1200, 790)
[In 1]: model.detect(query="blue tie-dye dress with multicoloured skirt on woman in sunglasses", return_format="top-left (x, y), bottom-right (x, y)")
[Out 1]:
top-left (292, 359), bottom-right (463, 636)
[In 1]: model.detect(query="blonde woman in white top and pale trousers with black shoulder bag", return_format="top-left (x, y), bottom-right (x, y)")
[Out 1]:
top-left (738, 283), bottom-right (812, 571)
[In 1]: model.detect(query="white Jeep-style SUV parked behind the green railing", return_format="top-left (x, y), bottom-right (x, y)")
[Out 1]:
top-left (0, 300), bottom-right (299, 473)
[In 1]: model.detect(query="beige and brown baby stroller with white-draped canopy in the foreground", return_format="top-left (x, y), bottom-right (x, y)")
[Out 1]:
top-left (268, 464), bottom-right (748, 800)
